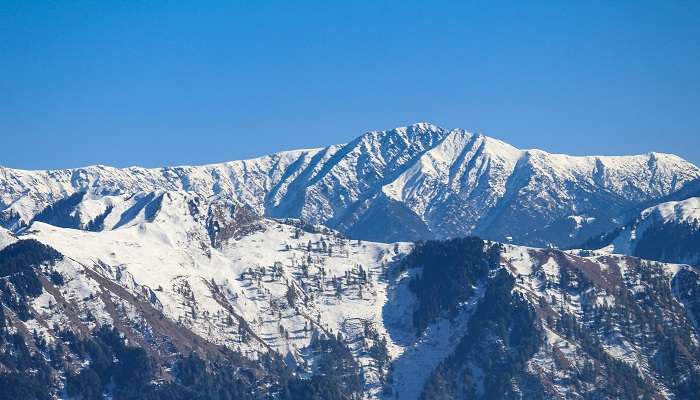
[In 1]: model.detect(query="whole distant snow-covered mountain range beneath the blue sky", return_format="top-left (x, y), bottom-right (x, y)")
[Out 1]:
top-left (0, 123), bottom-right (700, 247)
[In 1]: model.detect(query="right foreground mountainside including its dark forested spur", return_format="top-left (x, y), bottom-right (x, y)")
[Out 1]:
top-left (410, 242), bottom-right (700, 399)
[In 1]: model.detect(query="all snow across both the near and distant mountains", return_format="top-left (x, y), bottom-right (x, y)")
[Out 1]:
top-left (0, 123), bottom-right (700, 399)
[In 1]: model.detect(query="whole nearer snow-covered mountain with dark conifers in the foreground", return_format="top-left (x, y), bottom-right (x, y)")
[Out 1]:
top-left (5, 191), bottom-right (700, 399)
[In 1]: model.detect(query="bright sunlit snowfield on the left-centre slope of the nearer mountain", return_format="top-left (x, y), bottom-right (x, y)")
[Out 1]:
top-left (27, 192), bottom-right (422, 390)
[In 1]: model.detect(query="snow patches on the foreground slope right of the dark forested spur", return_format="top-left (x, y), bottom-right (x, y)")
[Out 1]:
top-left (503, 245), bottom-right (691, 397)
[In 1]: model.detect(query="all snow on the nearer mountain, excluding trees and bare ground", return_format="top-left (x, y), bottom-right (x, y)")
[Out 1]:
top-left (9, 195), bottom-right (696, 399)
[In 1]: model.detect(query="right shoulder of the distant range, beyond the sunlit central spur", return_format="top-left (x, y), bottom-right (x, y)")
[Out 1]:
top-left (477, 151), bottom-right (697, 247)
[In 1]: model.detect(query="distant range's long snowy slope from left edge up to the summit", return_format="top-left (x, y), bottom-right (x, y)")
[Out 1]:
top-left (0, 124), bottom-right (445, 233)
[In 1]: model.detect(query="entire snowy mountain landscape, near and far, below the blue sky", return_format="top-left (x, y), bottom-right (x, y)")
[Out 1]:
top-left (0, 123), bottom-right (700, 400)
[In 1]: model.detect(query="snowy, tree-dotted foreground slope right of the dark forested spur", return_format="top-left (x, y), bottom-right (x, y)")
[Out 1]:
top-left (503, 246), bottom-right (699, 398)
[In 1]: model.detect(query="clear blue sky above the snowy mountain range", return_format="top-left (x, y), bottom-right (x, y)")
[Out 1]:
top-left (0, 0), bottom-right (700, 169)
